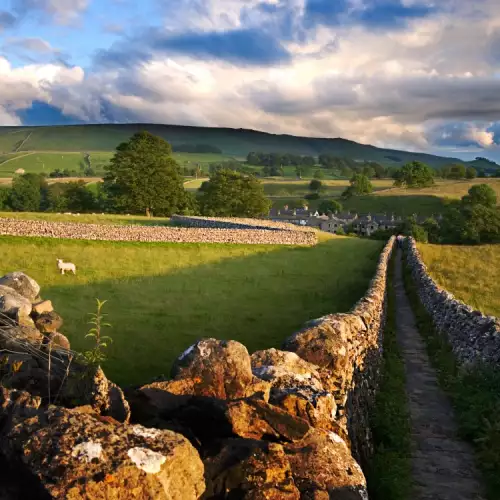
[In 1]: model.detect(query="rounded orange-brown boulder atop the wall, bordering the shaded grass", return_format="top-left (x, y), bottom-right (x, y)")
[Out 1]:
top-left (172, 339), bottom-right (253, 399)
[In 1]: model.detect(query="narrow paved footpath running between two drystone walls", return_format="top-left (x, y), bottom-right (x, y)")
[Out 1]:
top-left (394, 250), bottom-right (483, 500)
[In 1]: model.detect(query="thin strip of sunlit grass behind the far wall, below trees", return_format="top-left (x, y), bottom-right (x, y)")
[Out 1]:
top-left (0, 212), bottom-right (170, 226)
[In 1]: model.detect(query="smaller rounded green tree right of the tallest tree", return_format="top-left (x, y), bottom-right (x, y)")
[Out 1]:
top-left (200, 170), bottom-right (271, 217)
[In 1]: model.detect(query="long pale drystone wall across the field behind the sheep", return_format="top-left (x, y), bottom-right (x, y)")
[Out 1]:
top-left (0, 218), bottom-right (317, 246)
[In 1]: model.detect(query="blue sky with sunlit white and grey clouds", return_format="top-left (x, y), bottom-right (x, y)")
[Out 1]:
top-left (0, 0), bottom-right (500, 160)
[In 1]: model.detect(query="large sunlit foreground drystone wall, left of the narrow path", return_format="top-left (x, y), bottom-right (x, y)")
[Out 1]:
top-left (0, 237), bottom-right (395, 500)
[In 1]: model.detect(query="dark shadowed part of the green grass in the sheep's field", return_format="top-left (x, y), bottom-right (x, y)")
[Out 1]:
top-left (42, 238), bottom-right (383, 384)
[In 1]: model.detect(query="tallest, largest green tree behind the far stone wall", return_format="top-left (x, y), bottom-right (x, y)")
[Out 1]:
top-left (104, 132), bottom-right (189, 216)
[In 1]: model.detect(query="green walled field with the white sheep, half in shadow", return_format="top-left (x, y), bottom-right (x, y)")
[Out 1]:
top-left (0, 236), bottom-right (383, 384)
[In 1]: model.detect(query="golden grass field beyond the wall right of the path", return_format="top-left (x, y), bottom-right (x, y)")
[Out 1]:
top-left (418, 244), bottom-right (500, 317)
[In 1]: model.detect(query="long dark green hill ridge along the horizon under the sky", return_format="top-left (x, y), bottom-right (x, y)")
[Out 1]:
top-left (0, 124), bottom-right (491, 168)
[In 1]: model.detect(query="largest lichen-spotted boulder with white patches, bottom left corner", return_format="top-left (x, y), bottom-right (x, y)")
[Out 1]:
top-left (1, 407), bottom-right (205, 500)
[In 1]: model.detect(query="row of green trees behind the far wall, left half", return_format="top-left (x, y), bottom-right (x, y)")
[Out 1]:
top-left (0, 132), bottom-right (270, 217)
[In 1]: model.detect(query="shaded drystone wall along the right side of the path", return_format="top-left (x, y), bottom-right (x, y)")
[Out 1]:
top-left (407, 238), bottom-right (500, 364)
